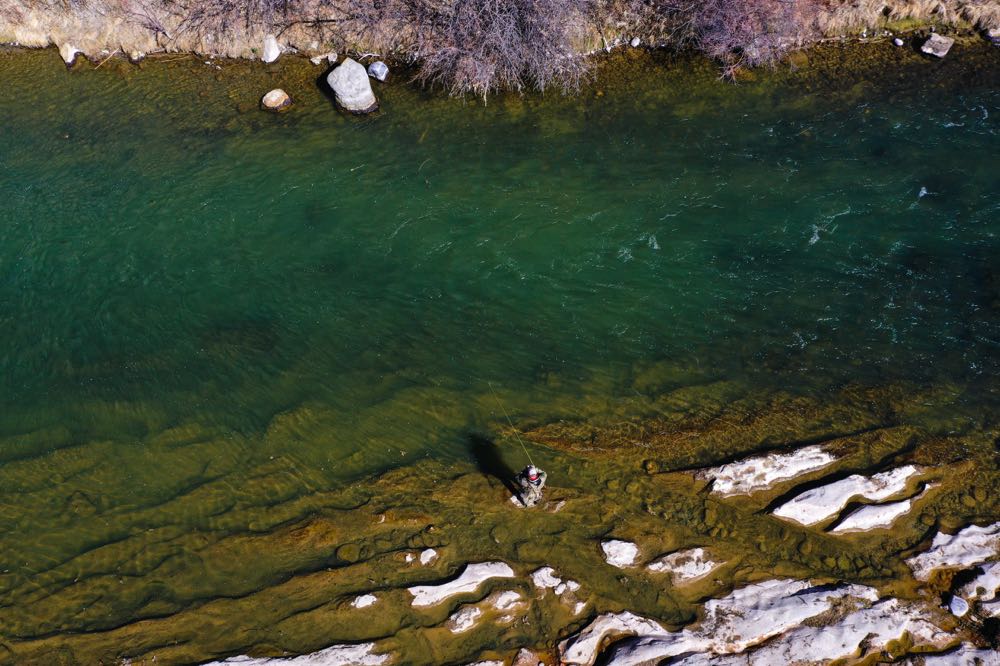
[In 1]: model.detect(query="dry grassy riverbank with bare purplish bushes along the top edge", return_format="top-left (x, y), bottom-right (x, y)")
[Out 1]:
top-left (0, 0), bottom-right (1000, 95)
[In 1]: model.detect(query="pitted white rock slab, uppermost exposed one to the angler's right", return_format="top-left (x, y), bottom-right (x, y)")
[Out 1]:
top-left (696, 444), bottom-right (836, 497)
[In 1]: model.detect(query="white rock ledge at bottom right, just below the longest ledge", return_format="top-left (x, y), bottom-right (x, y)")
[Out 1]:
top-left (749, 599), bottom-right (955, 664)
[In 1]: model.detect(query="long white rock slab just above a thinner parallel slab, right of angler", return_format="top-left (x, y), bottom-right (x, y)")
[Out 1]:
top-left (774, 465), bottom-right (921, 525)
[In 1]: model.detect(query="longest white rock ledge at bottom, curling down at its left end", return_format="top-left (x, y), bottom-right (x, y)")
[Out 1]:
top-left (559, 579), bottom-right (878, 666)
